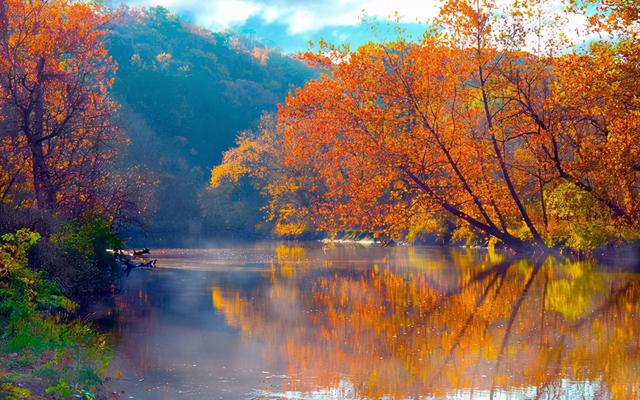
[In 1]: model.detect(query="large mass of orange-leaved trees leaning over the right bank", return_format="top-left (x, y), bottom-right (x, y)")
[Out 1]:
top-left (212, 0), bottom-right (640, 250)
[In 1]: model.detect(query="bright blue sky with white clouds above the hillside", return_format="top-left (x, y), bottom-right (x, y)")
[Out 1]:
top-left (114, 0), bottom-right (437, 53)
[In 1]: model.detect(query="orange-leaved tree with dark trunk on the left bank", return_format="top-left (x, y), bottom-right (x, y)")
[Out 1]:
top-left (0, 0), bottom-right (146, 216)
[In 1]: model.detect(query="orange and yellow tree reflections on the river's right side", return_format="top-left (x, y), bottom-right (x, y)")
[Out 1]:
top-left (212, 254), bottom-right (640, 398)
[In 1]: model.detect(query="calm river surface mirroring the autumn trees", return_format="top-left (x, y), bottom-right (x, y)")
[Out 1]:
top-left (87, 244), bottom-right (640, 399)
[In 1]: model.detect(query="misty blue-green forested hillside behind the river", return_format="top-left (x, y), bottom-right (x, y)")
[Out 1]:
top-left (106, 7), bottom-right (312, 239)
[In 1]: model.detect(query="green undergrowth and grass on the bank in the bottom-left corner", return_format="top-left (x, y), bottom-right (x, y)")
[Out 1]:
top-left (0, 229), bottom-right (108, 399)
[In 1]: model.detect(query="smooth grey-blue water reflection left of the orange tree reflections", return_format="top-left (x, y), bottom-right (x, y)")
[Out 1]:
top-left (102, 270), bottom-right (272, 400)
